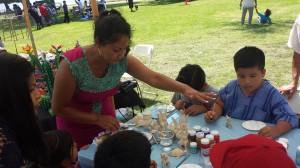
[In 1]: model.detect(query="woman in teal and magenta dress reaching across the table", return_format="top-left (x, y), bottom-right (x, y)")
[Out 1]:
top-left (52, 10), bottom-right (212, 148)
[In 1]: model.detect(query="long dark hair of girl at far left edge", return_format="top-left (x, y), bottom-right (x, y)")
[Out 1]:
top-left (0, 52), bottom-right (50, 163)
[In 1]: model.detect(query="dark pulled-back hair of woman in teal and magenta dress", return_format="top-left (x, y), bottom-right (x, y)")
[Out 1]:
top-left (94, 9), bottom-right (132, 56)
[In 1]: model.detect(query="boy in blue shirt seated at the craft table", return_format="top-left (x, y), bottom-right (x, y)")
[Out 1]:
top-left (205, 47), bottom-right (298, 139)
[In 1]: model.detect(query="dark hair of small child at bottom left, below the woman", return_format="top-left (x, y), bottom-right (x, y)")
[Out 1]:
top-left (41, 130), bottom-right (74, 168)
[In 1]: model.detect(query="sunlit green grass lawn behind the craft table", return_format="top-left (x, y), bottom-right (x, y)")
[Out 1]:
top-left (5, 0), bottom-right (300, 106)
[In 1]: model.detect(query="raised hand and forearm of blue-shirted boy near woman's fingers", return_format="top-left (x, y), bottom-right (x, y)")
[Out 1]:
top-left (204, 98), bottom-right (224, 122)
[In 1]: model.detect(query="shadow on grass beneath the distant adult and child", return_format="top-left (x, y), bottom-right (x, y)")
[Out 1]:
top-left (223, 20), bottom-right (294, 34)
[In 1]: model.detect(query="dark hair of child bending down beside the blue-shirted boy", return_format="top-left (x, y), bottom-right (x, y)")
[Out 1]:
top-left (176, 64), bottom-right (206, 91)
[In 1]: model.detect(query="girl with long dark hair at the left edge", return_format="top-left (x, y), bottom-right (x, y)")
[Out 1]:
top-left (0, 51), bottom-right (50, 167)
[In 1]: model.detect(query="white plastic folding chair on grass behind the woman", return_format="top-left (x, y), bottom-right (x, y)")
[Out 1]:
top-left (122, 44), bottom-right (158, 100)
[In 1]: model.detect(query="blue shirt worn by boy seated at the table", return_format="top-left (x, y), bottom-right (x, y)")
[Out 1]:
top-left (219, 80), bottom-right (298, 128)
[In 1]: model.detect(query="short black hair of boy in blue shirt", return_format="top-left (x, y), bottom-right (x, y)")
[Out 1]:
top-left (233, 46), bottom-right (265, 71)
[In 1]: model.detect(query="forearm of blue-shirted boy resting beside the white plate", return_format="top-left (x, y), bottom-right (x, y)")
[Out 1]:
top-left (258, 121), bottom-right (293, 139)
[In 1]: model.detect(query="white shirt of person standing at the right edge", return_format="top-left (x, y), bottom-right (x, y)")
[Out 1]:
top-left (288, 14), bottom-right (300, 54)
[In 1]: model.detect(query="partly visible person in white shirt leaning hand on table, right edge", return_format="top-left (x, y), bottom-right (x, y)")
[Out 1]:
top-left (279, 14), bottom-right (300, 98)
